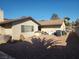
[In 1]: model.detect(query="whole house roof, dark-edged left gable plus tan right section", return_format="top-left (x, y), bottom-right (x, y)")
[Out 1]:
top-left (0, 17), bottom-right (63, 26)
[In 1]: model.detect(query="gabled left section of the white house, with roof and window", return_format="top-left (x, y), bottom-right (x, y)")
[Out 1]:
top-left (0, 17), bottom-right (40, 39)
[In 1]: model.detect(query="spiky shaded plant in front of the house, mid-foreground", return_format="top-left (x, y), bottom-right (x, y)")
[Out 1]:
top-left (31, 38), bottom-right (54, 49)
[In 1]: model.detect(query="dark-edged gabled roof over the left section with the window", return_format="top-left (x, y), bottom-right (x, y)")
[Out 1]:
top-left (0, 17), bottom-right (40, 25)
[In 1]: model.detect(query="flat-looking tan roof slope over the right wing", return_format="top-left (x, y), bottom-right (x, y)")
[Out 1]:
top-left (39, 19), bottom-right (63, 26)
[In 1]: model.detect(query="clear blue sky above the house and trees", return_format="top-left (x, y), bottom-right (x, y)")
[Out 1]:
top-left (0, 0), bottom-right (79, 21)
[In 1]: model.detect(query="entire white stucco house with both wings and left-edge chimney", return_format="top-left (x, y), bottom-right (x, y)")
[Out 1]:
top-left (0, 9), bottom-right (65, 39)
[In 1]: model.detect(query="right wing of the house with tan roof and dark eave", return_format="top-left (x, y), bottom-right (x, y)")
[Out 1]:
top-left (39, 19), bottom-right (65, 34)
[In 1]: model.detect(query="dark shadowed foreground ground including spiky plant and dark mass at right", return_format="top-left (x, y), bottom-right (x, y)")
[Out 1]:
top-left (0, 32), bottom-right (79, 59)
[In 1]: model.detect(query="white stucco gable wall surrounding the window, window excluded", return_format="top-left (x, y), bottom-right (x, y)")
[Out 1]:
top-left (12, 20), bottom-right (38, 39)
